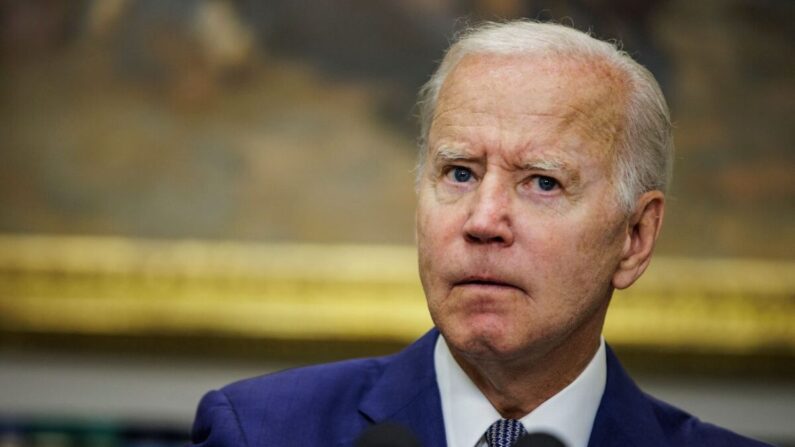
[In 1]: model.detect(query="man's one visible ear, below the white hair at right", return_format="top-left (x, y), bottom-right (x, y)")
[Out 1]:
top-left (613, 191), bottom-right (665, 289)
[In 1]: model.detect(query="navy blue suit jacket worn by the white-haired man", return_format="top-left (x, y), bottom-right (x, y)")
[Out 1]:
top-left (191, 329), bottom-right (764, 447)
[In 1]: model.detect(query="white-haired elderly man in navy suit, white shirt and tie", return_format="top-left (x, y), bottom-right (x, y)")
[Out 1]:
top-left (192, 22), bottom-right (761, 447)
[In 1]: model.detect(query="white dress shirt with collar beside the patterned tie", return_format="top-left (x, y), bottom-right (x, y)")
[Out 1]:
top-left (434, 335), bottom-right (607, 447)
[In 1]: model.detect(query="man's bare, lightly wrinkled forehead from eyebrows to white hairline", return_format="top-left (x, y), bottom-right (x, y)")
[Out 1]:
top-left (429, 54), bottom-right (627, 163)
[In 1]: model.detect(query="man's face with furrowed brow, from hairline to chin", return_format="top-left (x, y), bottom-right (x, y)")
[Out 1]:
top-left (417, 55), bottom-right (628, 360)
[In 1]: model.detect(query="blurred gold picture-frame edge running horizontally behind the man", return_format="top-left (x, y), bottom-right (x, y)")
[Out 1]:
top-left (0, 235), bottom-right (795, 357)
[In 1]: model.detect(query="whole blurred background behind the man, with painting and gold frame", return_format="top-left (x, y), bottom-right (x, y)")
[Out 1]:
top-left (0, 0), bottom-right (795, 446)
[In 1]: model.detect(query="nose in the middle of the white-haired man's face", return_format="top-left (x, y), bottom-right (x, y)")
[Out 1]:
top-left (463, 175), bottom-right (514, 247)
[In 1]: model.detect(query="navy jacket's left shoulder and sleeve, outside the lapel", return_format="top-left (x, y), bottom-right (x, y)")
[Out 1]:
top-left (191, 357), bottom-right (388, 447)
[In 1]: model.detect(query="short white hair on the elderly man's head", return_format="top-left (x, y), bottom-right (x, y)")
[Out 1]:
top-left (417, 20), bottom-right (673, 212)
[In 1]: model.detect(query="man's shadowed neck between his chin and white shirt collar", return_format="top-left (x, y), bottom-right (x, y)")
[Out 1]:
top-left (450, 307), bottom-right (607, 419)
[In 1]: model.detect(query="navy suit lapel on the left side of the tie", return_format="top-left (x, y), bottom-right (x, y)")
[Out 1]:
top-left (359, 329), bottom-right (446, 447)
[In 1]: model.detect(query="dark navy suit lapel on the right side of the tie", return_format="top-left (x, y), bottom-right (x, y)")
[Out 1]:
top-left (588, 346), bottom-right (667, 447)
